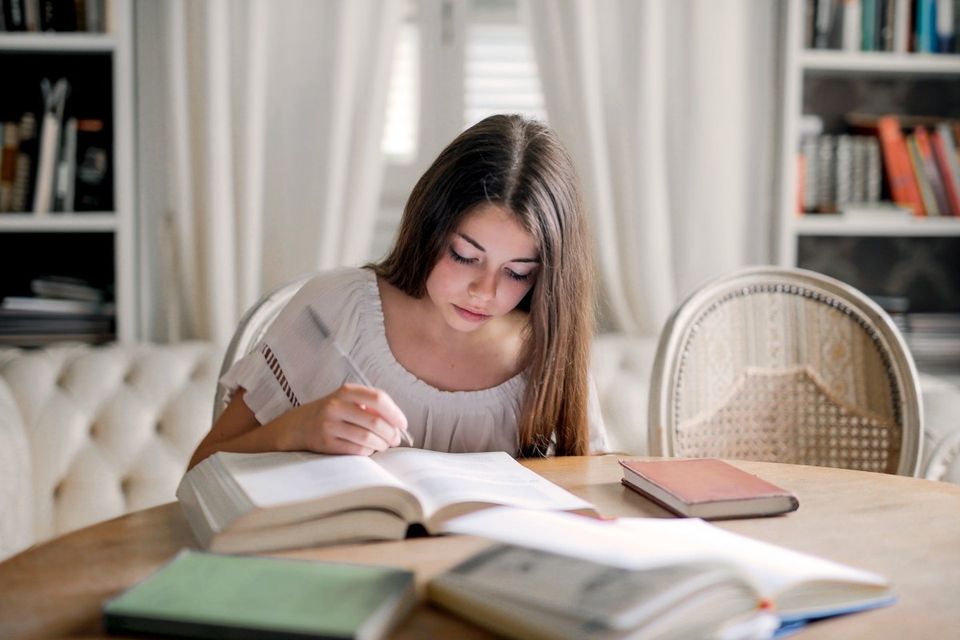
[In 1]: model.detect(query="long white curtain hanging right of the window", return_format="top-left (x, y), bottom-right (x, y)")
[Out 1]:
top-left (526, 0), bottom-right (777, 335)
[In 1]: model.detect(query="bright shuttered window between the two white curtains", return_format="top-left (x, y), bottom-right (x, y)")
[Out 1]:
top-left (381, 0), bottom-right (546, 190)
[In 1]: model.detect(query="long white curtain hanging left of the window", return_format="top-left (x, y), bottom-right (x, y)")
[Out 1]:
top-left (137, 0), bottom-right (402, 344)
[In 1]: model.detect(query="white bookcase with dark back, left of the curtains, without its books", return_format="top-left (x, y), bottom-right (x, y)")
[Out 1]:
top-left (0, 0), bottom-right (137, 346)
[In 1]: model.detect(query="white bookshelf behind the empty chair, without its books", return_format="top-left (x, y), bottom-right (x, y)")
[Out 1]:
top-left (774, 0), bottom-right (960, 371)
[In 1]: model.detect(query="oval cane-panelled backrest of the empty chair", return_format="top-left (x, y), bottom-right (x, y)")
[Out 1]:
top-left (648, 267), bottom-right (923, 475)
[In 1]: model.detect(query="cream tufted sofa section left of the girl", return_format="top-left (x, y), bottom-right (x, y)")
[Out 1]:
top-left (0, 343), bottom-right (220, 558)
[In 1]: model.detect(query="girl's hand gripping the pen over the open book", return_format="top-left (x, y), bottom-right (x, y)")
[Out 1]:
top-left (284, 384), bottom-right (407, 456)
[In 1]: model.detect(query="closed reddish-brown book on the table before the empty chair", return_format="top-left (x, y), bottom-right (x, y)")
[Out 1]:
top-left (620, 458), bottom-right (800, 519)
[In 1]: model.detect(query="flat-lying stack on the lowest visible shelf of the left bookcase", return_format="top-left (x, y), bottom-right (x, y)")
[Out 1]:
top-left (0, 277), bottom-right (116, 347)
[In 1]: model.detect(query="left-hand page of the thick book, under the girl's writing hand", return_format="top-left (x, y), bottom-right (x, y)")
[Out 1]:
top-left (217, 452), bottom-right (402, 507)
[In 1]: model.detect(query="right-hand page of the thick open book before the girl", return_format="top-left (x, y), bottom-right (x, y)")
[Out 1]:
top-left (372, 448), bottom-right (592, 519)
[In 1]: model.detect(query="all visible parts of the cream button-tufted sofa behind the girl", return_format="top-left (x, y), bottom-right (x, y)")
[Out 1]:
top-left (0, 334), bottom-right (960, 559)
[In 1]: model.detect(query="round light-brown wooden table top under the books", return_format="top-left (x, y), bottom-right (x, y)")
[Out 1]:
top-left (0, 456), bottom-right (960, 640)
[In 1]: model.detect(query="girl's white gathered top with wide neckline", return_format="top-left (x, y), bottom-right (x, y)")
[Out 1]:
top-left (220, 268), bottom-right (607, 456)
